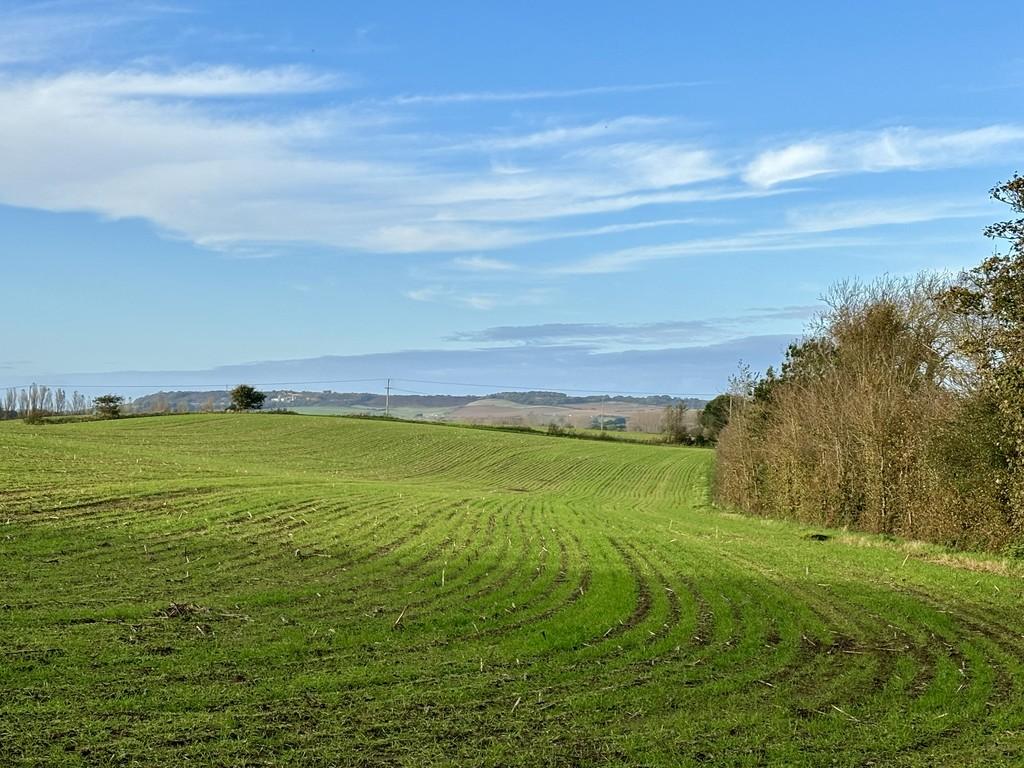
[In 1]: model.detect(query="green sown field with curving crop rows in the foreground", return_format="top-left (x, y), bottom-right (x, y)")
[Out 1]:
top-left (0, 415), bottom-right (1024, 766)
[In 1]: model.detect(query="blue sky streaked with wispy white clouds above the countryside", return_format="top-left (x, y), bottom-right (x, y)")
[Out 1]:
top-left (0, 0), bottom-right (1024, 395)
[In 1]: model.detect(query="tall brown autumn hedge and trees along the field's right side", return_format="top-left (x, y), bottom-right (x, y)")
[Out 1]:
top-left (715, 176), bottom-right (1024, 552)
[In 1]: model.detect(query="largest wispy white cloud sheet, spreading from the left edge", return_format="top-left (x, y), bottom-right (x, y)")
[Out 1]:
top-left (0, 67), bottom-right (737, 255)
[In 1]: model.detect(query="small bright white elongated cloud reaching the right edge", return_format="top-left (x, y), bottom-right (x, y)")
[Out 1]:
top-left (743, 125), bottom-right (1024, 186)
